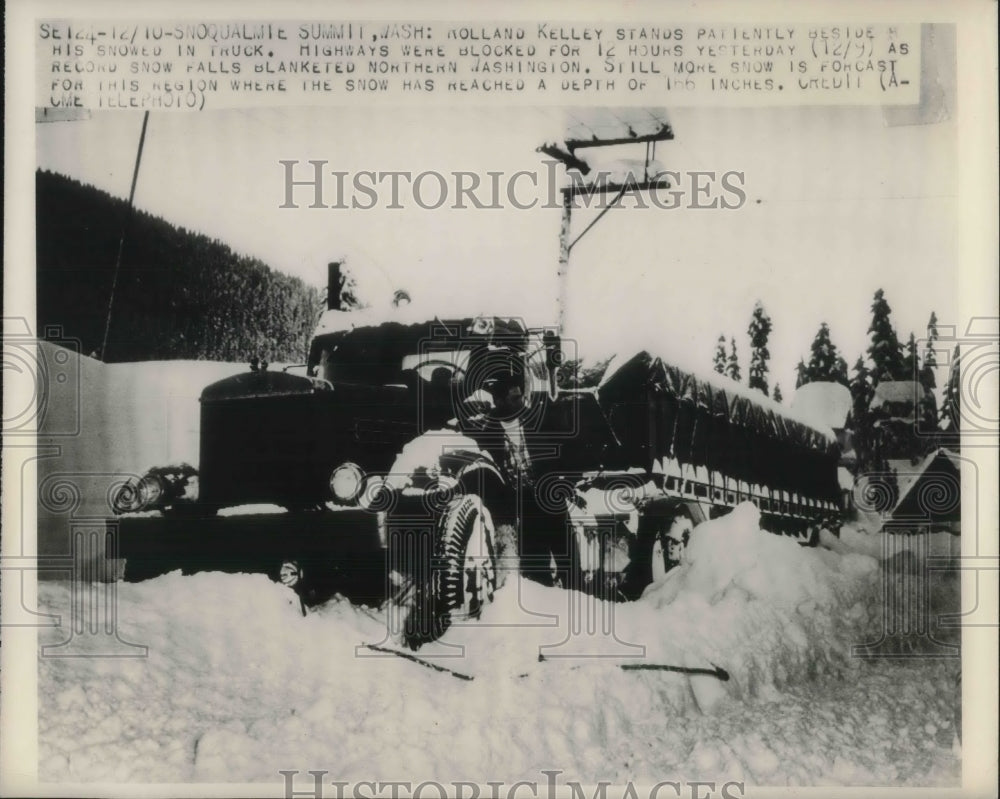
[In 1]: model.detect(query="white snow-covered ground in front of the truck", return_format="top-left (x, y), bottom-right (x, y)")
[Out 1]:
top-left (39, 506), bottom-right (961, 795)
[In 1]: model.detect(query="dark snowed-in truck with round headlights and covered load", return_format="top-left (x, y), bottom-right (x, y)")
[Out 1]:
top-left (108, 266), bottom-right (839, 641)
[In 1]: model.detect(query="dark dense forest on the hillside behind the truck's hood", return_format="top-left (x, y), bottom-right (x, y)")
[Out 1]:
top-left (35, 171), bottom-right (322, 362)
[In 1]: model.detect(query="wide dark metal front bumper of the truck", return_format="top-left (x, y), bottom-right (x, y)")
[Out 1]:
top-left (106, 509), bottom-right (386, 600)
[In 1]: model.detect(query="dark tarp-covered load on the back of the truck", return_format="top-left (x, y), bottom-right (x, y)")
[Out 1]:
top-left (598, 351), bottom-right (839, 500)
